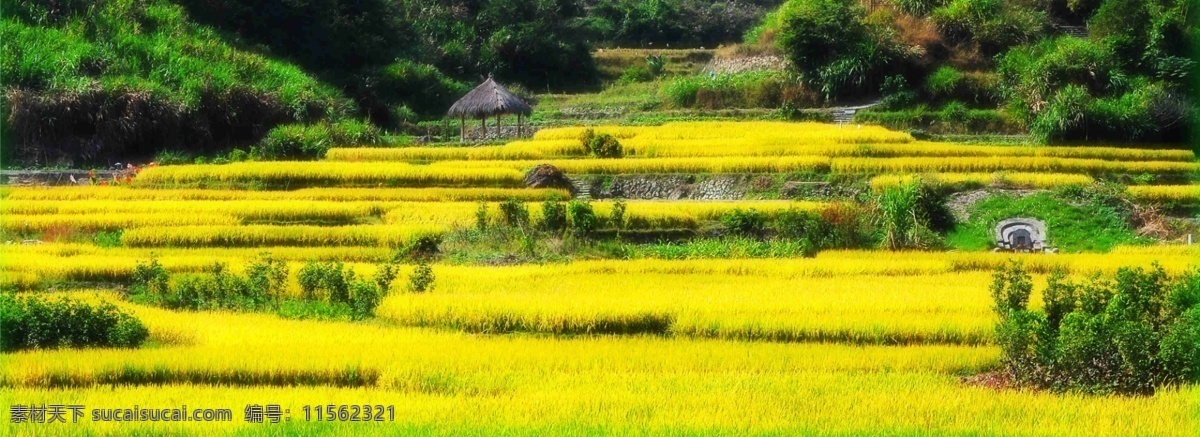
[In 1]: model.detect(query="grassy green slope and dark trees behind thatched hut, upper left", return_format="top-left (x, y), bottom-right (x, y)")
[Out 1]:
top-left (0, 0), bottom-right (778, 164)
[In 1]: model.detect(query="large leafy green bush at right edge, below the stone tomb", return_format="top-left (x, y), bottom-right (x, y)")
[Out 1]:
top-left (991, 262), bottom-right (1200, 395)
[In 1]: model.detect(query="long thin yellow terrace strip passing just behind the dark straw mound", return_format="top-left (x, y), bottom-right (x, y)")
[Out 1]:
top-left (129, 156), bottom-right (1200, 187)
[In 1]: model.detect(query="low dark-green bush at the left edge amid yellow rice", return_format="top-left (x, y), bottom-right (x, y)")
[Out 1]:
top-left (0, 293), bottom-right (150, 352)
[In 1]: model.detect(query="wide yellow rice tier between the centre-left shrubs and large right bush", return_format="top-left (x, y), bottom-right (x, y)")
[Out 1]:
top-left (376, 269), bottom-right (995, 345)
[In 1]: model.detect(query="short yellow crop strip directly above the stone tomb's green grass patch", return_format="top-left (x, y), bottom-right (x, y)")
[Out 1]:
top-left (870, 173), bottom-right (1096, 190)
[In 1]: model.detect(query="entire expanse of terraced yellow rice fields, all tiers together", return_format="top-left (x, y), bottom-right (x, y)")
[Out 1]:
top-left (0, 122), bottom-right (1200, 437)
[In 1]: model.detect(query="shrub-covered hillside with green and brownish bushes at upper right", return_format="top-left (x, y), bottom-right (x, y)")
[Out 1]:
top-left (745, 0), bottom-right (1200, 142)
